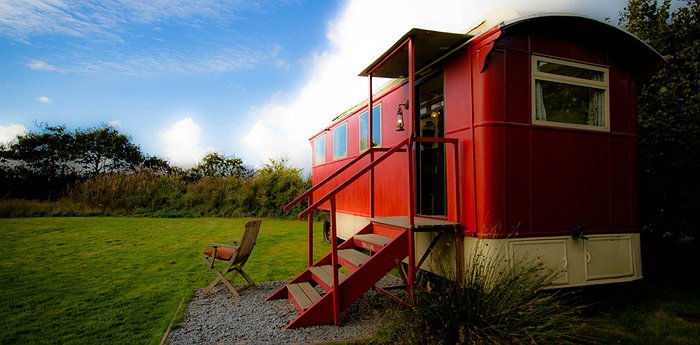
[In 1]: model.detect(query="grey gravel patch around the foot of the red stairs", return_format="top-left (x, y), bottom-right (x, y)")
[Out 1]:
top-left (168, 278), bottom-right (400, 345)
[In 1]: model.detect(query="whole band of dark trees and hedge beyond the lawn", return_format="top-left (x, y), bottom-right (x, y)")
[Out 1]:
top-left (0, 124), bottom-right (311, 217)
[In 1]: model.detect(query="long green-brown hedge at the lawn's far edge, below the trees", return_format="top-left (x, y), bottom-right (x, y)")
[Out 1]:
top-left (0, 158), bottom-right (311, 218)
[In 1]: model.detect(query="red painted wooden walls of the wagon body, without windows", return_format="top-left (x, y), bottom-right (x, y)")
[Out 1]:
top-left (306, 18), bottom-right (652, 237)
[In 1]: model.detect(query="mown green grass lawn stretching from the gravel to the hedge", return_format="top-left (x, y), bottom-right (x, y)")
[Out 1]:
top-left (0, 218), bottom-right (329, 344)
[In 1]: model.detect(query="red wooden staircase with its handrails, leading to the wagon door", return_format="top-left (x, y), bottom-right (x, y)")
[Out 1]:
top-left (266, 136), bottom-right (461, 328)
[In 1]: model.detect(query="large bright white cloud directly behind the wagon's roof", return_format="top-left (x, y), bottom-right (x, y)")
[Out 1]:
top-left (241, 0), bottom-right (627, 168)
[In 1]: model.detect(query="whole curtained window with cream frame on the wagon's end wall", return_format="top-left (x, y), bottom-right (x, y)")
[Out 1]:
top-left (532, 56), bottom-right (609, 130)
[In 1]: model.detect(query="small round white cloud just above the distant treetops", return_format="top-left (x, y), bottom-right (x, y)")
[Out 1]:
top-left (159, 117), bottom-right (213, 168)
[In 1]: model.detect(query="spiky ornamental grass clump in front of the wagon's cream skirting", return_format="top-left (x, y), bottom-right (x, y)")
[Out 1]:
top-left (380, 242), bottom-right (593, 344)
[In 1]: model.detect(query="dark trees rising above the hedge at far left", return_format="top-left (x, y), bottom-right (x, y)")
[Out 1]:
top-left (0, 123), bottom-right (149, 198)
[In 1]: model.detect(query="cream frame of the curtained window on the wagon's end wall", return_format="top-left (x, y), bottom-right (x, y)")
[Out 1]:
top-left (530, 55), bottom-right (610, 132)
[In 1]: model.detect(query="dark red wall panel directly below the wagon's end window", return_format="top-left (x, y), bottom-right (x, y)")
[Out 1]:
top-left (532, 129), bottom-right (610, 234)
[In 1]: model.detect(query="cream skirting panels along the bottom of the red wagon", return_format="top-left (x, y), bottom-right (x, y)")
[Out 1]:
top-left (337, 212), bottom-right (642, 288)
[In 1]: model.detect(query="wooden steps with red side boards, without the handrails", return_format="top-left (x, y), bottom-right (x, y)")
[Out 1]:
top-left (266, 223), bottom-right (409, 328)
